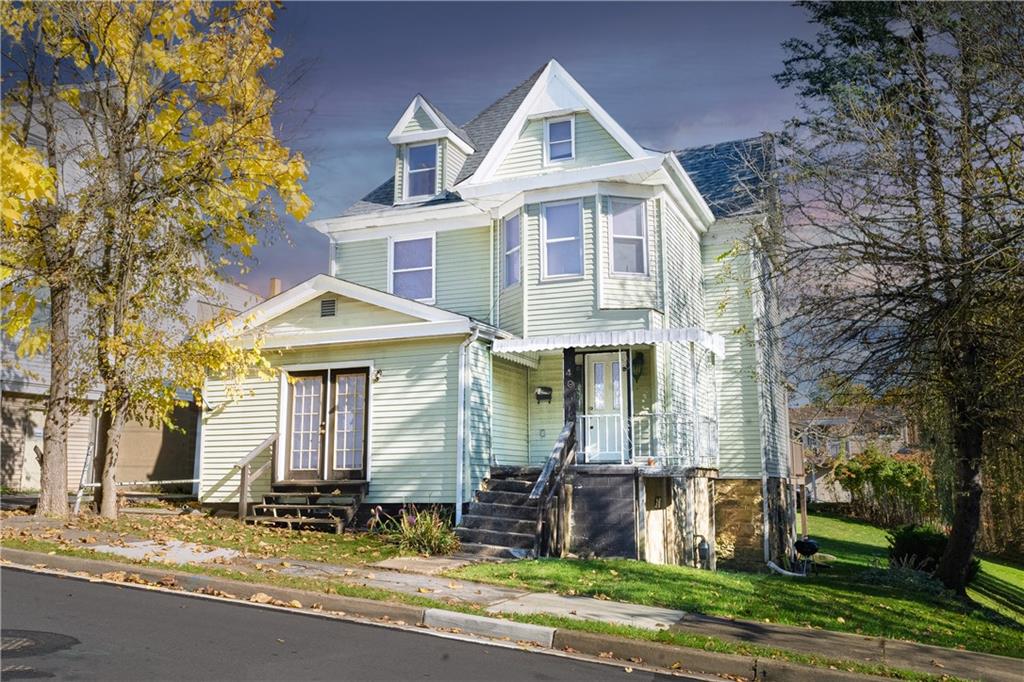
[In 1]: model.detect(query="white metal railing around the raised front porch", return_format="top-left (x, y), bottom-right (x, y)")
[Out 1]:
top-left (577, 413), bottom-right (718, 469)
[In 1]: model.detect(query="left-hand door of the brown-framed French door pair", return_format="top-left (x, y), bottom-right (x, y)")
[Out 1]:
top-left (287, 372), bottom-right (326, 480)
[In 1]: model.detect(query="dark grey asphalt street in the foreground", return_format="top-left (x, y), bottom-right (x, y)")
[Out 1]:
top-left (0, 568), bottom-right (692, 682)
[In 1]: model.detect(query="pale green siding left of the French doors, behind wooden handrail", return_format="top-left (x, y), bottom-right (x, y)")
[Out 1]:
top-left (199, 377), bottom-right (281, 504)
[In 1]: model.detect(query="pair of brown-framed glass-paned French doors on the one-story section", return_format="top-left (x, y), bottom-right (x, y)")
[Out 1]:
top-left (285, 368), bottom-right (369, 481)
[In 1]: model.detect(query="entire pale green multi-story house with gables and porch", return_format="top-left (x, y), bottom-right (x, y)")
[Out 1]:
top-left (200, 60), bottom-right (792, 564)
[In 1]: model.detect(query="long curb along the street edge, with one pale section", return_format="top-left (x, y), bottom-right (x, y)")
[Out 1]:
top-left (0, 548), bottom-right (879, 682)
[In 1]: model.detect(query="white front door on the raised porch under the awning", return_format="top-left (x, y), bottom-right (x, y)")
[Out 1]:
top-left (581, 352), bottom-right (626, 463)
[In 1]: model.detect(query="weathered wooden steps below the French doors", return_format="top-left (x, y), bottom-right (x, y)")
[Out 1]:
top-left (246, 481), bottom-right (366, 532)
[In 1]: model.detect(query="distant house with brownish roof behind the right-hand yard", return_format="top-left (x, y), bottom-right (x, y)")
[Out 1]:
top-left (790, 404), bottom-right (918, 503)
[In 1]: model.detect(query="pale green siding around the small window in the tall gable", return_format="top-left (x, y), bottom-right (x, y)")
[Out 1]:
top-left (495, 113), bottom-right (630, 177)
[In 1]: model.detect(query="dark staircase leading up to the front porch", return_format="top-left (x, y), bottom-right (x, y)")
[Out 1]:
top-left (455, 467), bottom-right (541, 559)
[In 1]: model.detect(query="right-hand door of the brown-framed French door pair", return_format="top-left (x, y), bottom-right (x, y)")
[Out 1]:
top-left (328, 370), bottom-right (368, 479)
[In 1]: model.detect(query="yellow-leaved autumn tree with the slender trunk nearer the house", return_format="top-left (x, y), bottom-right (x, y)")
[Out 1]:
top-left (3, 2), bottom-right (310, 516)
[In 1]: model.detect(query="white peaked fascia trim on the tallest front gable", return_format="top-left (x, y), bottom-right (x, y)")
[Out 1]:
top-left (468, 59), bottom-right (660, 184)
